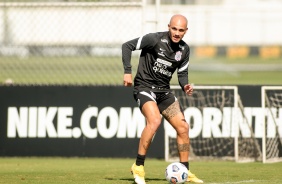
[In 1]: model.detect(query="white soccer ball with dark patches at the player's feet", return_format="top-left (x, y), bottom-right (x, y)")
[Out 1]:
top-left (165, 162), bottom-right (188, 184)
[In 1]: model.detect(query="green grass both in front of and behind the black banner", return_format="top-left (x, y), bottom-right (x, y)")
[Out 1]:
top-left (0, 57), bottom-right (282, 184)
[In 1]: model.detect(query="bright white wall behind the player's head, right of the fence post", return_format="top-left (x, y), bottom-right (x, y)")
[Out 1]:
top-left (159, 5), bottom-right (282, 45)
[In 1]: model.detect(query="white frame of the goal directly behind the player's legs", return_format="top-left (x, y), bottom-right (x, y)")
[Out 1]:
top-left (165, 85), bottom-right (240, 162)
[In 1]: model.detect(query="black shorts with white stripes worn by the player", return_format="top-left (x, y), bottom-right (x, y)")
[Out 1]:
top-left (134, 90), bottom-right (177, 113)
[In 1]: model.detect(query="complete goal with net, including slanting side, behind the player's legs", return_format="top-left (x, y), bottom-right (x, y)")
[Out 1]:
top-left (164, 86), bottom-right (261, 161)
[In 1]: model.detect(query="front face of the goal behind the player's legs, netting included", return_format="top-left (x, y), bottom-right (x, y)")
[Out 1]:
top-left (164, 86), bottom-right (238, 161)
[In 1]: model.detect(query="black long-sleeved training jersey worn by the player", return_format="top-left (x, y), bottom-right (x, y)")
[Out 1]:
top-left (122, 31), bottom-right (190, 92)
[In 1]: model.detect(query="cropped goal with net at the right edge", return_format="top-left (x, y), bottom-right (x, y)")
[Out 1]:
top-left (261, 86), bottom-right (282, 163)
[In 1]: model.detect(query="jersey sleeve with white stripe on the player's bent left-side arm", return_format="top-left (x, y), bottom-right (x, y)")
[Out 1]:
top-left (122, 33), bottom-right (157, 73)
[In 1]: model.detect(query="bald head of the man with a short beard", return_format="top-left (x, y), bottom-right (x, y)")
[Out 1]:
top-left (168, 14), bottom-right (188, 43)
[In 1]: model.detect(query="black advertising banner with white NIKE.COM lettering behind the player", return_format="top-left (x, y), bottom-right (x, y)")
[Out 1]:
top-left (0, 85), bottom-right (282, 159)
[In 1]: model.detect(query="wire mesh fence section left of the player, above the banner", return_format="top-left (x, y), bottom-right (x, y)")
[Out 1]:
top-left (0, 1), bottom-right (148, 85)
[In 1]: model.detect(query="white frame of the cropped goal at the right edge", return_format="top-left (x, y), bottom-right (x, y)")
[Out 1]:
top-left (261, 86), bottom-right (282, 163)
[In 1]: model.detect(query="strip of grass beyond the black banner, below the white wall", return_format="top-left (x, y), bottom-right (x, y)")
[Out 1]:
top-left (0, 56), bottom-right (282, 85)
